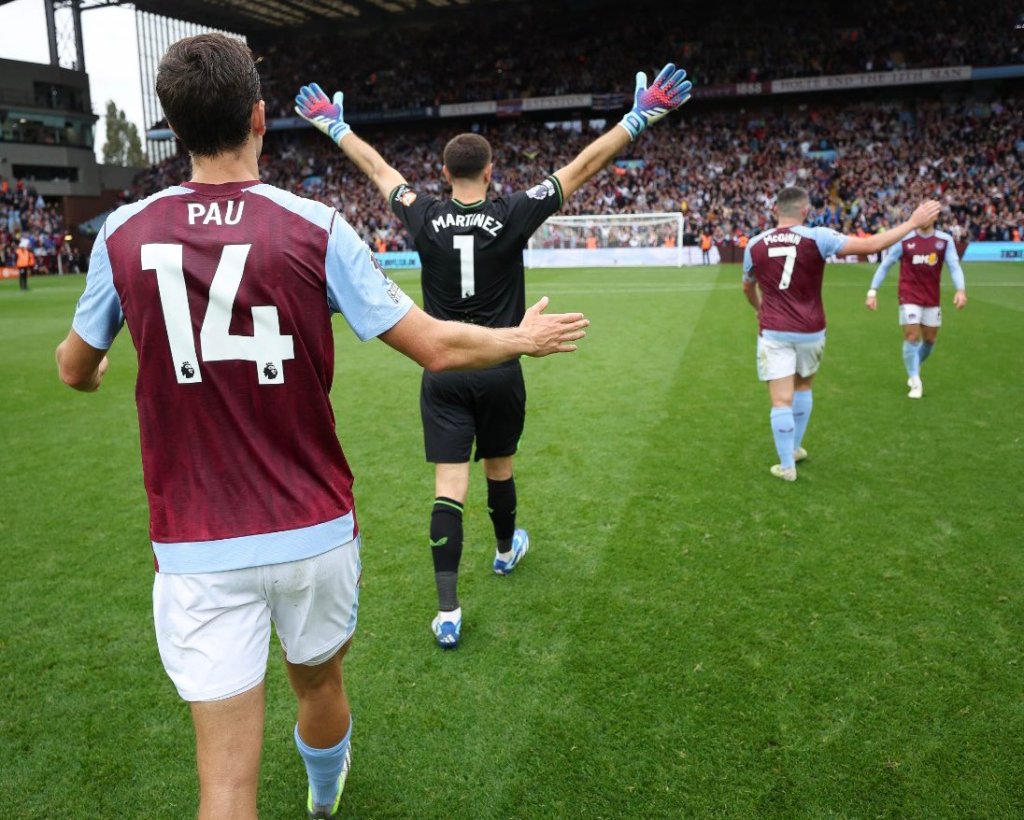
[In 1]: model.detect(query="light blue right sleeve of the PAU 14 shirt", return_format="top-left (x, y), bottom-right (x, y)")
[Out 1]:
top-left (326, 216), bottom-right (413, 342)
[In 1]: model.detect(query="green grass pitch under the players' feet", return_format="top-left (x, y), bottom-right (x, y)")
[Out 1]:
top-left (0, 264), bottom-right (1024, 820)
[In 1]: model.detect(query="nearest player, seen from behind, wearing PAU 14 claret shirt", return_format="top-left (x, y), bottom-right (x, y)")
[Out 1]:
top-left (56, 34), bottom-right (587, 819)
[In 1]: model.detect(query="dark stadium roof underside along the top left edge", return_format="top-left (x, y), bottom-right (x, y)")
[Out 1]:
top-left (0, 0), bottom-right (536, 36)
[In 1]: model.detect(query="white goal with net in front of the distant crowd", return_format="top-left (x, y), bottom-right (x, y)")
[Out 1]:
top-left (524, 213), bottom-right (689, 267)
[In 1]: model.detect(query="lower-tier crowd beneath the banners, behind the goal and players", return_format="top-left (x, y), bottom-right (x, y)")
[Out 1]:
top-left (135, 92), bottom-right (1024, 250)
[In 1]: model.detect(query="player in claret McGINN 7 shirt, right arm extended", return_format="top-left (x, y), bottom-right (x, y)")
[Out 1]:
top-left (743, 187), bottom-right (940, 481)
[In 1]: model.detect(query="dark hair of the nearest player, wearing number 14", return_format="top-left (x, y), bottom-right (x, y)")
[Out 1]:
top-left (157, 34), bottom-right (261, 157)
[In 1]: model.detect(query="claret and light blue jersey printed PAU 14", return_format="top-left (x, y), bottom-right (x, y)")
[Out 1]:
top-left (73, 181), bottom-right (412, 572)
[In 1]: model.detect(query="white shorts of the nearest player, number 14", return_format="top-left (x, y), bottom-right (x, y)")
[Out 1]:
top-left (153, 537), bottom-right (361, 701)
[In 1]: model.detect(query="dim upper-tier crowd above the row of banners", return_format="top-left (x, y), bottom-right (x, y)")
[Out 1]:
top-left (254, 0), bottom-right (1024, 117)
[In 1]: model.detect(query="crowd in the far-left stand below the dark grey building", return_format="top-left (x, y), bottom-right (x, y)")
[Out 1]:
top-left (0, 178), bottom-right (80, 273)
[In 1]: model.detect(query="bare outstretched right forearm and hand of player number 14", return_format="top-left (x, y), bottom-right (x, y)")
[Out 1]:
top-left (380, 296), bottom-right (590, 371)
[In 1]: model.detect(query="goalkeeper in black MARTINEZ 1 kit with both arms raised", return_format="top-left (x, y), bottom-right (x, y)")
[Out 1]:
top-left (295, 63), bottom-right (691, 649)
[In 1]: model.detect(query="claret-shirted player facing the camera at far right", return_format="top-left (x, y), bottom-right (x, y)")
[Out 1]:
top-left (865, 210), bottom-right (967, 398)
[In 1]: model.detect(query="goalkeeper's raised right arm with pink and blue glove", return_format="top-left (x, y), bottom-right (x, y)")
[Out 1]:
top-left (555, 62), bottom-right (693, 197)
